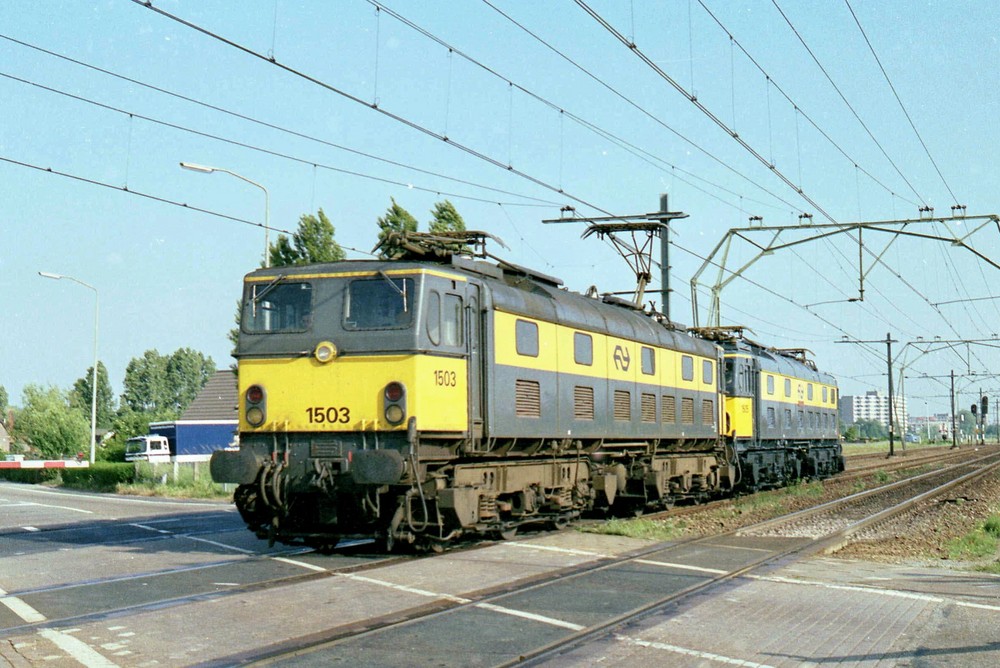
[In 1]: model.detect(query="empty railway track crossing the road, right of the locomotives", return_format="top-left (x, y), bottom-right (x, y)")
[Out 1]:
top-left (211, 452), bottom-right (1000, 666)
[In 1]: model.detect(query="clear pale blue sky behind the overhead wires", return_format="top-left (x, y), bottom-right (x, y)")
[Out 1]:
top-left (0, 0), bottom-right (1000, 413)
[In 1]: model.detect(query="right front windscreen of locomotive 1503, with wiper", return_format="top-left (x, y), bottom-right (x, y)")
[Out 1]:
top-left (344, 276), bottom-right (414, 330)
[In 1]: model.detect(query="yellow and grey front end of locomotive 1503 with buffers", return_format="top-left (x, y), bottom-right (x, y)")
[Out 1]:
top-left (211, 262), bottom-right (469, 546)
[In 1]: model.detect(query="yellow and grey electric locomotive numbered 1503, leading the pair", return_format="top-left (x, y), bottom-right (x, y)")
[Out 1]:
top-left (211, 233), bottom-right (737, 548)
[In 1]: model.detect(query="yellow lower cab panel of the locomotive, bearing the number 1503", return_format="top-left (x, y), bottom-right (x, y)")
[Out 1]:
top-left (239, 355), bottom-right (469, 432)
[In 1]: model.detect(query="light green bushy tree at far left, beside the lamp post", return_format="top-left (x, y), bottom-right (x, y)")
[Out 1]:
top-left (14, 385), bottom-right (90, 459)
